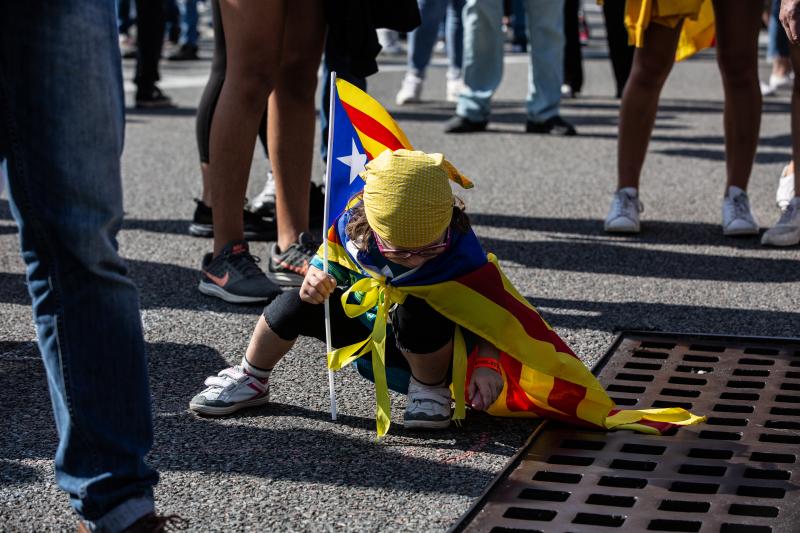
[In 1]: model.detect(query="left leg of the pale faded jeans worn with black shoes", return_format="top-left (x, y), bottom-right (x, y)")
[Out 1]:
top-left (456, 0), bottom-right (504, 122)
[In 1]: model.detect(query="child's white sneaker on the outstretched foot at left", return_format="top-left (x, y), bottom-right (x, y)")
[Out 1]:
top-left (189, 365), bottom-right (269, 416)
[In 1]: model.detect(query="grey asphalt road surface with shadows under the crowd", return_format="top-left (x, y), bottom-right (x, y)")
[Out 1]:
top-left (0, 9), bottom-right (800, 531)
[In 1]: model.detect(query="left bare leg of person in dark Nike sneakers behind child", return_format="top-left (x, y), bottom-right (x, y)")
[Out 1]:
top-left (208, 0), bottom-right (287, 256)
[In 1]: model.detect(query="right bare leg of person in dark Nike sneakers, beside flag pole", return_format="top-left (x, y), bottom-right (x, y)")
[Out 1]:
top-left (266, 1), bottom-right (325, 250)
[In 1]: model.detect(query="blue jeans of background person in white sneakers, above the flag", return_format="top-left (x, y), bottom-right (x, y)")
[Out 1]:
top-left (408, 0), bottom-right (465, 80)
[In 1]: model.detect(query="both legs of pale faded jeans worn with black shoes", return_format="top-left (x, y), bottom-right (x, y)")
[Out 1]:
top-left (456, 0), bottom-right (564, 122)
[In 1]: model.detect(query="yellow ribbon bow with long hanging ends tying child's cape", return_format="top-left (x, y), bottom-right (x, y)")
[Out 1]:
top-left (328, 278), bottom-right (467, 437)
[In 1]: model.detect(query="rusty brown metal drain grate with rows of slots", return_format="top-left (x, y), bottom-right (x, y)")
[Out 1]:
top-left (451, 332), bottom-right (800, 533)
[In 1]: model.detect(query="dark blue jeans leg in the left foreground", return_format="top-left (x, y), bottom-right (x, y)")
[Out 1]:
top-left (0, 0), bottom-right (158, 532)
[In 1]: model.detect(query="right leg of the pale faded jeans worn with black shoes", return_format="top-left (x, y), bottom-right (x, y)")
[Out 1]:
top-left (526, 0), bottom-right (564, 122)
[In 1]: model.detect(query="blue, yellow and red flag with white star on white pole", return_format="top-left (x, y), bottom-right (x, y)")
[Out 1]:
top-left (325, 78), bottom-right (413, 228)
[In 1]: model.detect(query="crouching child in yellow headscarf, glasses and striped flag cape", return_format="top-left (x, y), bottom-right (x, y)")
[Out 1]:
top-left (189, 150), bottom-right (704, 436)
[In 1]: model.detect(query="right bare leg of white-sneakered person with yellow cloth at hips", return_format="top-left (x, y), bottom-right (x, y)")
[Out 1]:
top-left (714, 0), bottom-right (763, 191)
